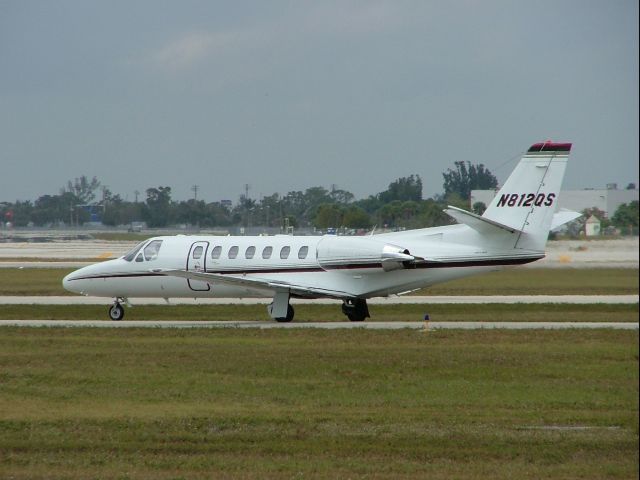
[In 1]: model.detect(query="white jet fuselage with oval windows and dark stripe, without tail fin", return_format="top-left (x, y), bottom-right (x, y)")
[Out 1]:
top-left (63, 225), bottom-right (543, 298)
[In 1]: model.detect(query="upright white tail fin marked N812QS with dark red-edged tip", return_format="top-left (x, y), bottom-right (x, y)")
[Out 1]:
top-left (482, 142), bottom-right (571, 251)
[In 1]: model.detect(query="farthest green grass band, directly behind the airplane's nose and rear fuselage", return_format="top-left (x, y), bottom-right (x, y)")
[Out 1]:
top-left (0, 268), bottom-right (639, 295)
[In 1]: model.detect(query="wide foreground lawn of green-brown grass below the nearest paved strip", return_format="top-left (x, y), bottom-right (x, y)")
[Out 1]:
top-left (0, 328), bottom-right (638, 479)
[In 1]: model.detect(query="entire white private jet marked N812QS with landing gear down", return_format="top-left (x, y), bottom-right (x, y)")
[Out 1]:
top-left (62, 141), bottom-right (580, 322)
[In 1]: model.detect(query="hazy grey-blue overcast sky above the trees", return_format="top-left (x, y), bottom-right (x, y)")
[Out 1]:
top-left (0, 0), bottom-right (639, 202)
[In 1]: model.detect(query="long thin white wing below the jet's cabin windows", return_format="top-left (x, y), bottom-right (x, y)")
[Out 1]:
top-left (152, 269), bottom-right (353, 299)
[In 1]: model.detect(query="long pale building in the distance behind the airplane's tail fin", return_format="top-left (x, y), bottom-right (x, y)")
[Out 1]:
top-left (470, 183), bottom-right (638, 217)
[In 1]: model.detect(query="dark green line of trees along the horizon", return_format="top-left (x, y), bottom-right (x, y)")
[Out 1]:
top-left (0, 161), bottom-right (638, 234)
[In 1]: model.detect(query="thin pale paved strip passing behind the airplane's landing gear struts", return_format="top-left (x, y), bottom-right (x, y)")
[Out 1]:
top-left (0, 295), bottom-right (639, 305)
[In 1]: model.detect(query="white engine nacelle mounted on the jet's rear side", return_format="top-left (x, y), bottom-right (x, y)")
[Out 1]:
top-left (317, 236), bottom-right (415, 271)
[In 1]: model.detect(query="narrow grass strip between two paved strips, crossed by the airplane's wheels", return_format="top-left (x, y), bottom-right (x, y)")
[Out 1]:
top-left (0, 303), bottom-right (638, 322)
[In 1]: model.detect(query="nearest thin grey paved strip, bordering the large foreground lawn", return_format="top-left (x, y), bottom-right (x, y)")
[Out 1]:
top-left (0, 320), bottom-right (638, 332)
